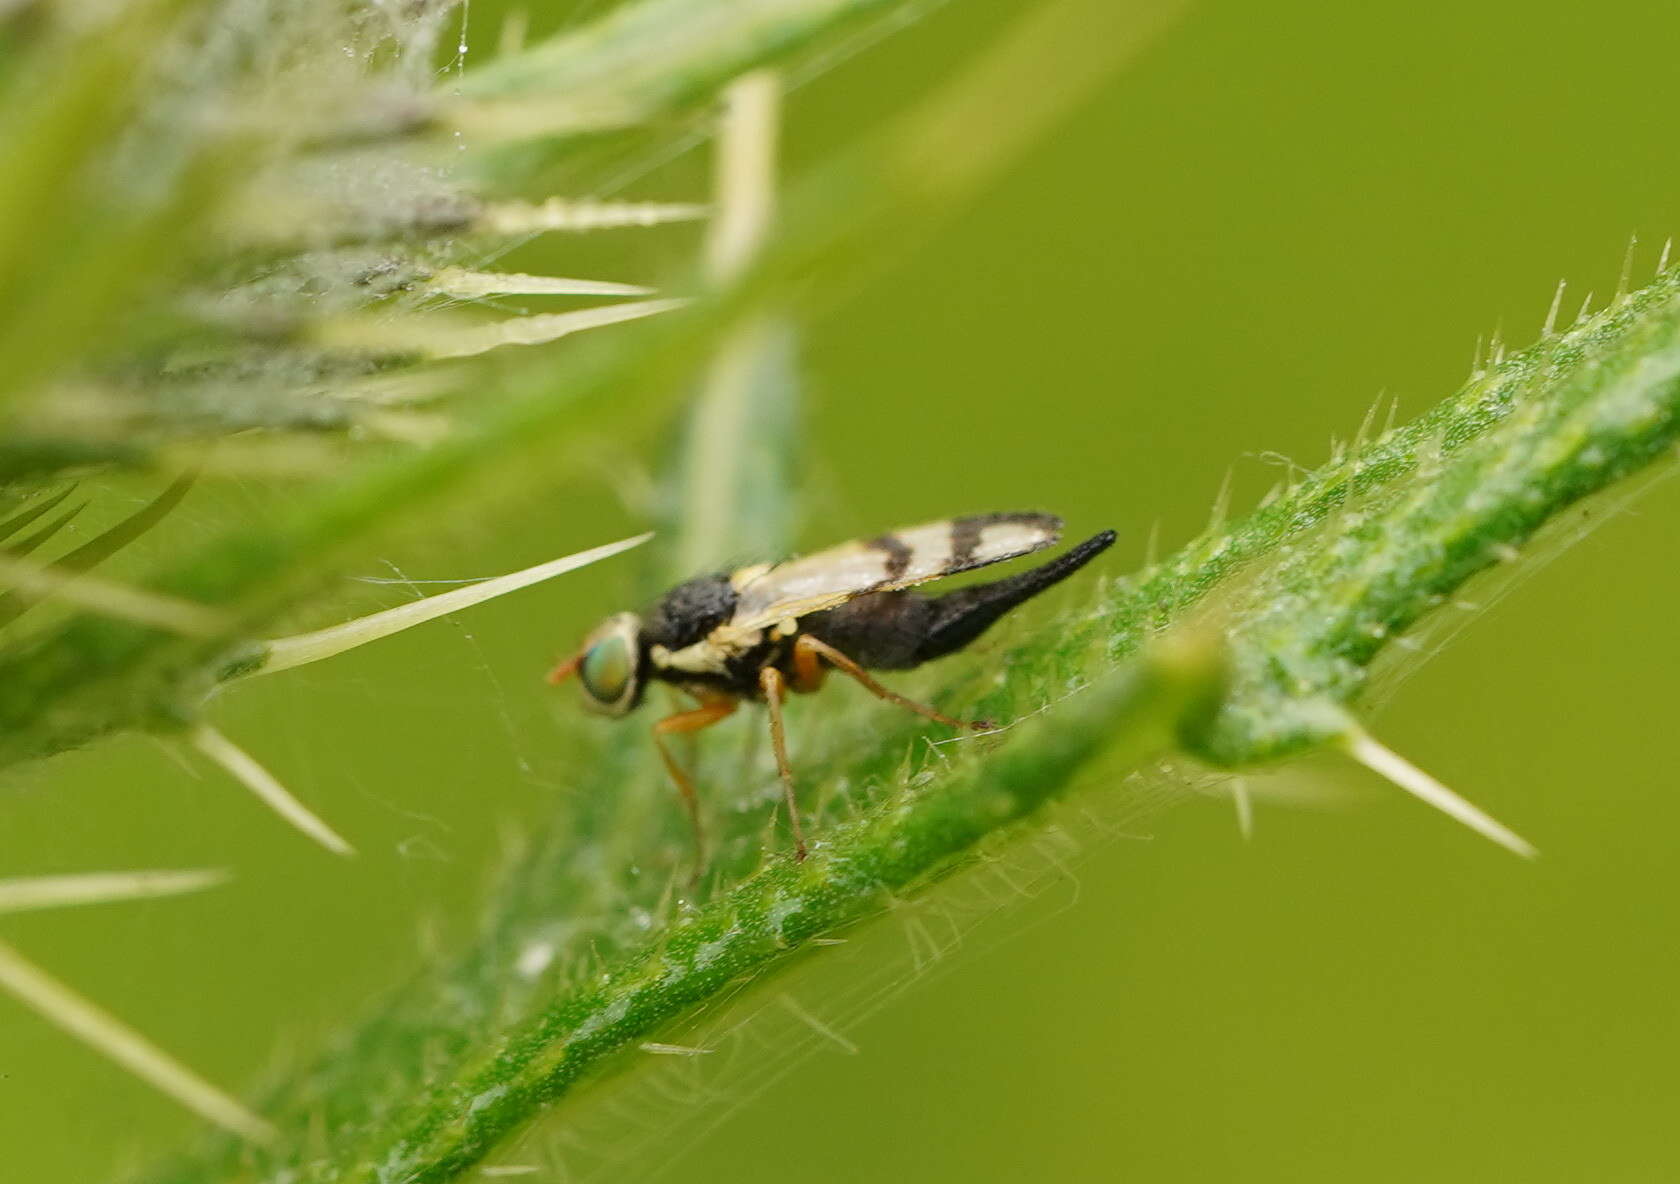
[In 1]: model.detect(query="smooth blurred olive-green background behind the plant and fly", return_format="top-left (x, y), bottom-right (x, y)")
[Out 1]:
top-left (0, 0), bottom-right (1680, 1182)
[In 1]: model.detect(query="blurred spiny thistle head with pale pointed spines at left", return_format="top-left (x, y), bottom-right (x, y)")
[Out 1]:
top-left (0, 0), bottom-right (940, 1140)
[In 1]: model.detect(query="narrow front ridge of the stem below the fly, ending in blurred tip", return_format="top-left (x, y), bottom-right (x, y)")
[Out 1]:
top-left (357, 647), bottom-right (1220, 1184)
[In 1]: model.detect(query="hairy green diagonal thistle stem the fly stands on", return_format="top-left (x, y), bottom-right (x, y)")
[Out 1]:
top-left (141, 272), bottom-right (1680, 1182)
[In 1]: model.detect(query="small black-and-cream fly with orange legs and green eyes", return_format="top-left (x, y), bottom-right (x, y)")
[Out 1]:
top-left (548, 512), bottom-right (1114, 862)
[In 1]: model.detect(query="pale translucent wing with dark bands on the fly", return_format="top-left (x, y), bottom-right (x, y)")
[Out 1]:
top-left (731, 512), bottom-right (1062, 628)
